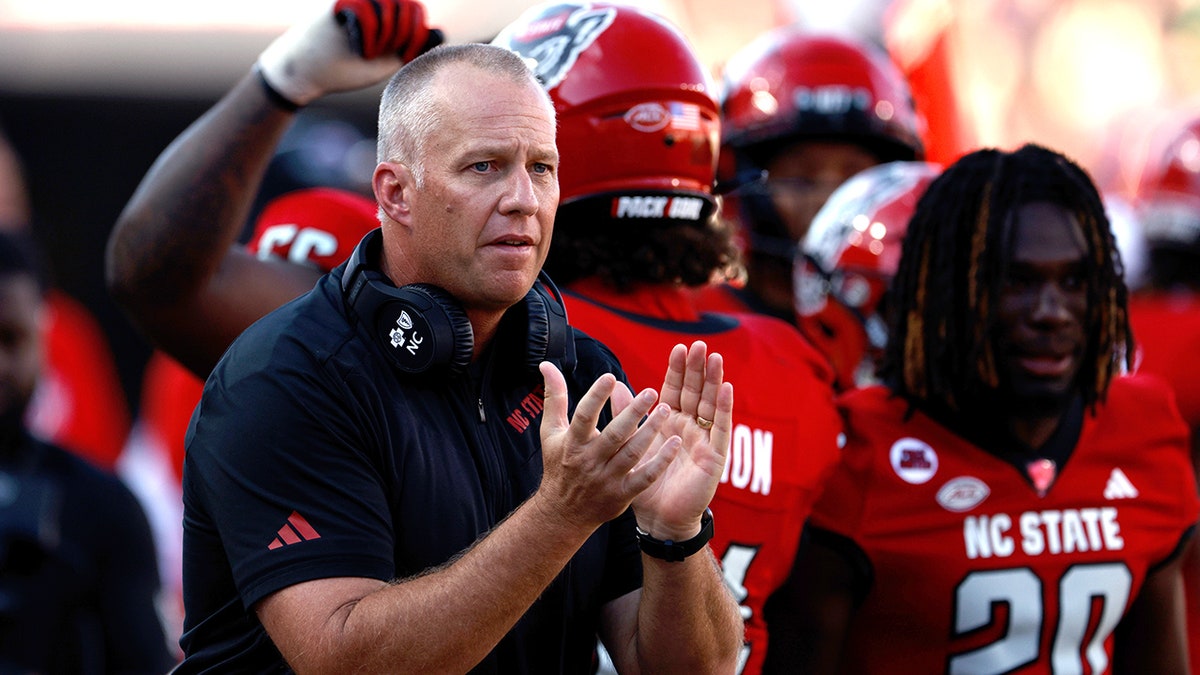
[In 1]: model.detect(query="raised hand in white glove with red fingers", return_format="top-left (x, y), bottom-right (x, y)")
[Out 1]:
top-left (257, 0), bottom-right (444, 107)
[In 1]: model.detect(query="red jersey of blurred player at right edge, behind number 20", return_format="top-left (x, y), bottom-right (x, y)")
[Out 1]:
top-left (1129, 292), bottom-right (1200, 673)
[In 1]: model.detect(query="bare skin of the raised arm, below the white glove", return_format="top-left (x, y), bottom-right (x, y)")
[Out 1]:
top-left (106, 76), bottom-right (316, 377)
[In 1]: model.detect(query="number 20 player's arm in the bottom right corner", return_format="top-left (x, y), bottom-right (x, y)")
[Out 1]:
top-left (1112, 536), bottom-right (1194, 675)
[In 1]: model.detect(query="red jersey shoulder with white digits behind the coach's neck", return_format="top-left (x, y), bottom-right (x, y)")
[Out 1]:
top-left (246, 187), bottom-right (379, 271)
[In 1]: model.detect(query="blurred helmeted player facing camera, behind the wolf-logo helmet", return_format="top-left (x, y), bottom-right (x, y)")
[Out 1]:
top-left (701, 26), bottom-right (924, 322)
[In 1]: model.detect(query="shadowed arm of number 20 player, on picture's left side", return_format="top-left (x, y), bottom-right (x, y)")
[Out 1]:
top-left (762, 527), bottom-right (870, 675)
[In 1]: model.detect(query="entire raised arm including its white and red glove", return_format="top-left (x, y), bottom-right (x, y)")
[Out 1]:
top-left (106, 0), bottom-right (440, 376)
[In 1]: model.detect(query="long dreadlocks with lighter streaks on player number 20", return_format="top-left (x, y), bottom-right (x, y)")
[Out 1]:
top-left (880, 144), bottom-right (1133, 411)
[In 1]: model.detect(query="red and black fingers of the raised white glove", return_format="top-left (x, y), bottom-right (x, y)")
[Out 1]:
top-left (334, 0), bottom-right (445, 64)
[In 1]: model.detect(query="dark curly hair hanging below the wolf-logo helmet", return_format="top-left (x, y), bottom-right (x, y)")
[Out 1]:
top-left (542, 194), bottom-right (738, 292)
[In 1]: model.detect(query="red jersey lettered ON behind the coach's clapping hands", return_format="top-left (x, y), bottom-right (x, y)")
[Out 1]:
top-left (565, 280), bottom-right (840, 673)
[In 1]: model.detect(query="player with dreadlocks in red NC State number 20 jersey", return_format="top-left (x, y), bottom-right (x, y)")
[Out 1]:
top-left (768, 145), bottom-right (1200, 674)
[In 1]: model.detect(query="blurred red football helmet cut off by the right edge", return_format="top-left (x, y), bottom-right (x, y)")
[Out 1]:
top-left (1135, 111), bottom-right (1200, 283)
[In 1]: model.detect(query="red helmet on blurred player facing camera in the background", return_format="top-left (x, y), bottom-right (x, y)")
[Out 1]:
top-left (721, 26), bottom-right (924, 167)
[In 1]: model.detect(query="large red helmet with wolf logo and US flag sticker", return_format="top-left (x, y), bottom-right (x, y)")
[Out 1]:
top-left (492, 2), bottom-right (720, 220)
